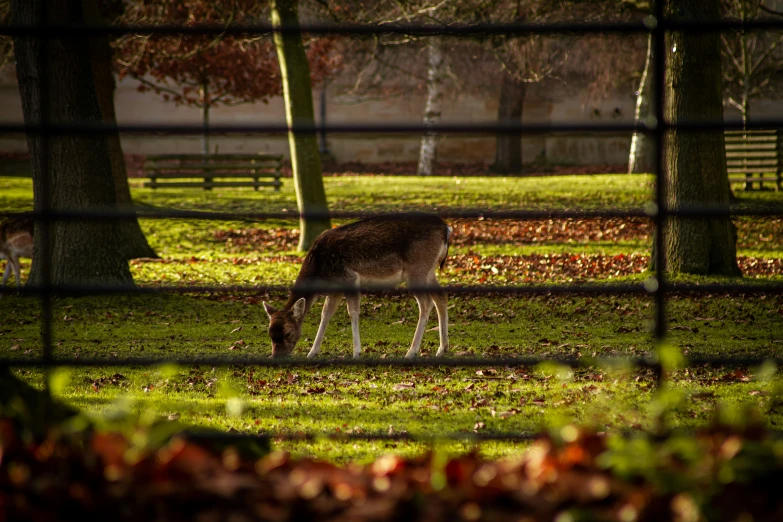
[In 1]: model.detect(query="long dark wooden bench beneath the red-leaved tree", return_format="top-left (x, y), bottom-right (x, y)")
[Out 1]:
top-left (144, 154), bottom-right (283, 191)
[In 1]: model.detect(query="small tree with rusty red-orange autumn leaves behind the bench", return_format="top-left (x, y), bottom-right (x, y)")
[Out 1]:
top-left (115, 0), bottom-right (339, 154)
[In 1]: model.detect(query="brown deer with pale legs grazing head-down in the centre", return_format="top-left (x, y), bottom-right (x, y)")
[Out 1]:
top-left (264, 214), bottom-right (451, 359)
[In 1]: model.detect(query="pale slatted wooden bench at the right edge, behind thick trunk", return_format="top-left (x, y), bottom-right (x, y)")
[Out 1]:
top-left (726, 130), bottom-right (783, 191)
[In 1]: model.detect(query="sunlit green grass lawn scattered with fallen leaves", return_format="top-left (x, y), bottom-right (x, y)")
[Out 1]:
top-left (0, 171), bottom-right (783, 462)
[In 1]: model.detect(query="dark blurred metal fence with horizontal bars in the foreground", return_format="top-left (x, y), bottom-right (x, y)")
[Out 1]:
top-left (0, 2), bottom-right (783, 441)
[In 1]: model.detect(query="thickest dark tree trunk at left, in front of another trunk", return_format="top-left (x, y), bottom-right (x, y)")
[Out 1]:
top-left (12, 0), bottom-right (133, 285)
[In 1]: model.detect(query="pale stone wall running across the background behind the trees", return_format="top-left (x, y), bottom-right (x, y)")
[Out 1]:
top-left (0, 69), bottom-right (781, 165)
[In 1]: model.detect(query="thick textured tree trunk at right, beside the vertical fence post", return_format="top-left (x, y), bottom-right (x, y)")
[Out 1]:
top-left (664, 0), bottom-right (742, 276)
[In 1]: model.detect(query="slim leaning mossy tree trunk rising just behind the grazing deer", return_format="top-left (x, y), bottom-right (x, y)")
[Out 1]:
top-left (272, 0), bottom-right (331, 251)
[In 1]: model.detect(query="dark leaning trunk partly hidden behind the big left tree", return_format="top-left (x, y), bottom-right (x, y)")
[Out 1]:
top-left (84, 0), bottom-right (158, 259)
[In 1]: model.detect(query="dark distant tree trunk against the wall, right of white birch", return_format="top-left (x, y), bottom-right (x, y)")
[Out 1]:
top-left (491, 74), bottom-right (527, 174)
